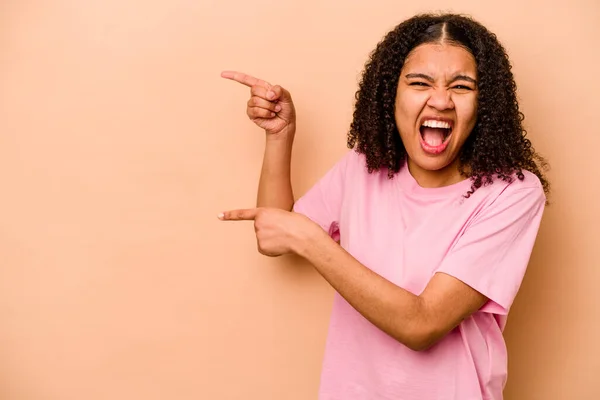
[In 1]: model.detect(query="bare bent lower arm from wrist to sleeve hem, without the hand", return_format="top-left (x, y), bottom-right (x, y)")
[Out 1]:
top-left (296, 231), bottom-right (487, 351)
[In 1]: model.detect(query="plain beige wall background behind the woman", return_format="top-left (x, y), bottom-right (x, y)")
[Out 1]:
top-left (0, 0), bottom-right (600, 400)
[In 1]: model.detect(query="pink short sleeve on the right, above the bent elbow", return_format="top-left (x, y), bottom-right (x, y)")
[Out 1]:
top-left (437, 185), bottom-right (546, 315)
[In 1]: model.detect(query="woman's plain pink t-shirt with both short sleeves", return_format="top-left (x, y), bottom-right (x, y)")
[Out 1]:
top-left (294, 150), bottom-right (546, 400)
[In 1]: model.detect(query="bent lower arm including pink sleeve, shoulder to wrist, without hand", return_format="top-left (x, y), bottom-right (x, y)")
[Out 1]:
top-left (292, 185), bottom-right (545, 350)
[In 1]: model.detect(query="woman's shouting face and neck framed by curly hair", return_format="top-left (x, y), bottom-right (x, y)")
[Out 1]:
top-left (395, 43), bottom-right (477, 187)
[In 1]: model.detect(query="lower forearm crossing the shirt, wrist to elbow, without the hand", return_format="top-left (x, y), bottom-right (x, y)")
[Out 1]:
top-left (297, 234), bottom-right (433, 350)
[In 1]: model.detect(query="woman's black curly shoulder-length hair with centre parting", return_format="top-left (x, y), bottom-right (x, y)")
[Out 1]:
top-left (348, 14), bottom-right (550, 197)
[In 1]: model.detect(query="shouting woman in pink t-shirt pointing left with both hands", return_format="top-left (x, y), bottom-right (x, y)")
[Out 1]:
top-left (219, 14), bottom-right (548, 400)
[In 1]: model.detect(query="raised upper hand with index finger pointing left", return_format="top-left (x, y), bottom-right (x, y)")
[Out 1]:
top-left (221, 71), bottom-right (296, 135)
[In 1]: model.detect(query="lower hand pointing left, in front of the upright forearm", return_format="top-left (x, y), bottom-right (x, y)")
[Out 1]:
top-left (219, 208), bottom-right (325, 257)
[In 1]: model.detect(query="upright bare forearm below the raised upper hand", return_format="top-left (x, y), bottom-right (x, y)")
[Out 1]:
top-left (256, 126), bottom-right (296, 211)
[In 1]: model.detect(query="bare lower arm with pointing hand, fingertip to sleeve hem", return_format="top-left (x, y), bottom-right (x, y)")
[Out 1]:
top-left (219, 208), bottom-right (487, 350)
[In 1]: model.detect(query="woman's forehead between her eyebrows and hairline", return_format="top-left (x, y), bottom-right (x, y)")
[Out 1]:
top-left (402, 43), bottom-right (477, 76)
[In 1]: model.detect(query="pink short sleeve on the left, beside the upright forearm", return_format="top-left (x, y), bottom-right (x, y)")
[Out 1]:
top-left (293, 151), bottom-right (355, 240)
